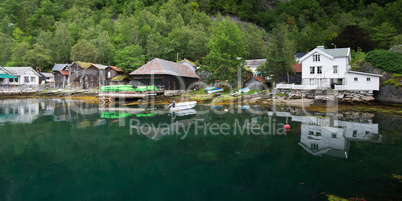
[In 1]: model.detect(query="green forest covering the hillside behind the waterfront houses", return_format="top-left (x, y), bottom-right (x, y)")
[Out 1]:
top-left (0, 0), bottom-right (402, 72)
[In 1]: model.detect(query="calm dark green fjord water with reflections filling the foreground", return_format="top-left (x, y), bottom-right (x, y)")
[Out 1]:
top-left (0, 99), bottom-right (402, 200)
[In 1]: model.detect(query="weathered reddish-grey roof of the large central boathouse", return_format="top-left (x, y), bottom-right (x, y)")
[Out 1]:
top-left (130, 58), bottom-right (200, 79)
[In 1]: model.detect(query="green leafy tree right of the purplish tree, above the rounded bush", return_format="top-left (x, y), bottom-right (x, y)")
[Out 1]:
top-left (373, 22), bottom-right (397, 49)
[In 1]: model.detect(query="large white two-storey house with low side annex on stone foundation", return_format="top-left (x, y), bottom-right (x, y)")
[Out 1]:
top-left (300, 46), bottom-right (381, 90)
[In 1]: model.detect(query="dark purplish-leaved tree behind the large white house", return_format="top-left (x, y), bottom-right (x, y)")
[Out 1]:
top-left (333, 25), bottom-right (374, 52)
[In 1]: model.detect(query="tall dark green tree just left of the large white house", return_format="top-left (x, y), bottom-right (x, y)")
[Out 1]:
top-left (257, 23), bottom-right (296, 83)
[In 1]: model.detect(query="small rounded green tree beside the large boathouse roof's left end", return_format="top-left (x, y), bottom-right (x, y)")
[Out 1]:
top-left (114, 45), bottom-right (145, 72)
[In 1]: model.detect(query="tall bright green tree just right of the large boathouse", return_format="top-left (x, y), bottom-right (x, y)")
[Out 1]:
top-left (205, 19), bottom-right (248, 84)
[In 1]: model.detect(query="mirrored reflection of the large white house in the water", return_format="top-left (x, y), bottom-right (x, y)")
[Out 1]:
top-left (276, 112), bottom-right (382, 158)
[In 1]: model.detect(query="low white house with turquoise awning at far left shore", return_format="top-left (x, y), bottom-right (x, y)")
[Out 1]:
top-left (0, 66), bottom-right (40, 85)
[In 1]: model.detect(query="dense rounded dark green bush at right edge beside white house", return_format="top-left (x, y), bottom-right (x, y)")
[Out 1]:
top-left (364, 50), bottom-right (402, 73)
